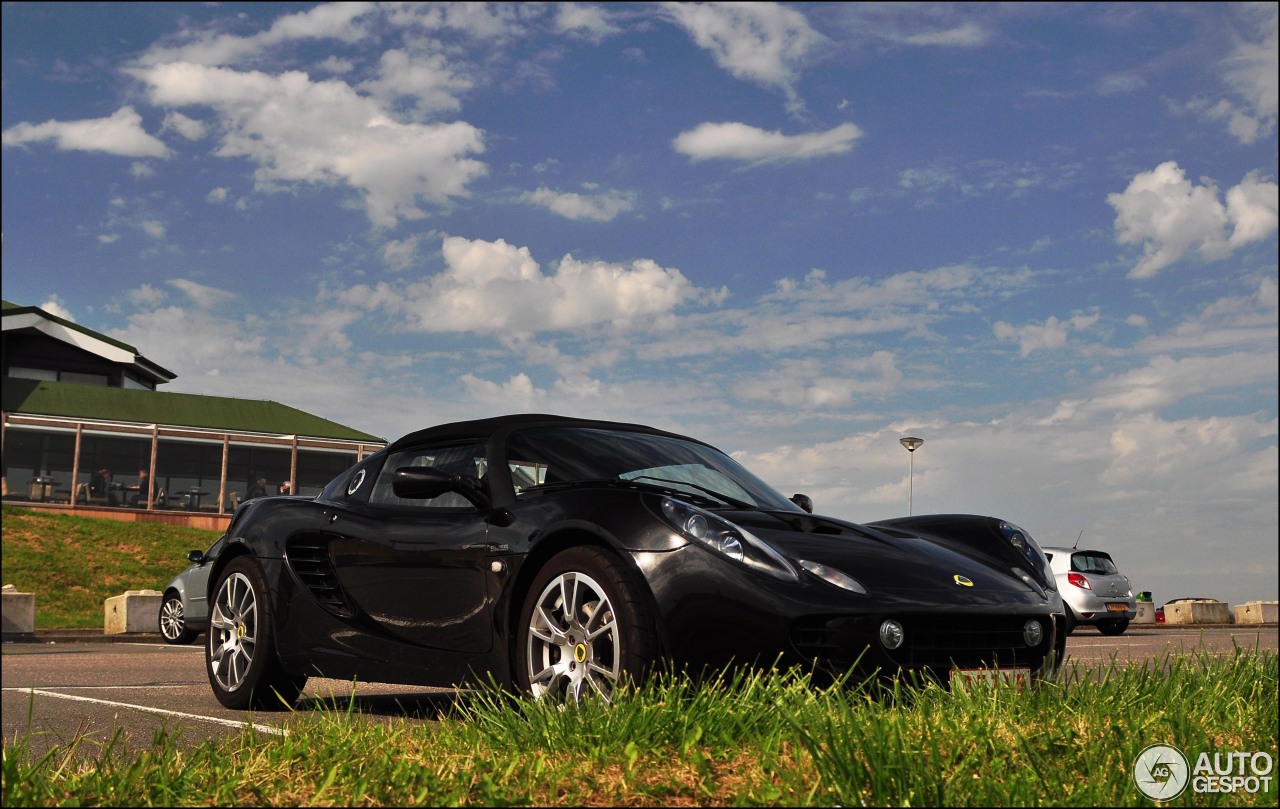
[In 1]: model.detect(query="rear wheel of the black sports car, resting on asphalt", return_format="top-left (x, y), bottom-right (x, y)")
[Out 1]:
top-left (205, 557), bottom-right (307, 710)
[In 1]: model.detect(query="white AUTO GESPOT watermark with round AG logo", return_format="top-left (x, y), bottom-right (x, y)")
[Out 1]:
top-left (1133, 745), bottom-right (1275, 801)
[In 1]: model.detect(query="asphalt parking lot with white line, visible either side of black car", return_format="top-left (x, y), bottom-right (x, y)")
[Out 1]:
top-left (0, 625), bottom-right (1277, 758)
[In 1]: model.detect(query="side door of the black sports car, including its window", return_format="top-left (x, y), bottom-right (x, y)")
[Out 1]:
top-left (325, 444), bottom-right (493, 654)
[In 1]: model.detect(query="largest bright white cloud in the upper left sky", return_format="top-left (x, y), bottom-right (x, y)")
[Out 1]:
top-left (134, 63), bottom-right (486, 227)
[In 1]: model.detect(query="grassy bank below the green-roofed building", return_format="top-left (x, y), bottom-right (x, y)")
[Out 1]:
top-left (0, 506), bottom-right (218, 629)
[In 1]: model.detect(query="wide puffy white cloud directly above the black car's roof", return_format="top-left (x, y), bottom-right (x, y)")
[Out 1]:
top-left (337, 237), bottom-right (705, 334)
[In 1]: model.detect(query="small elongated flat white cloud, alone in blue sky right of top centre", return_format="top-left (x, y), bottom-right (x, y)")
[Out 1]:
top-left (673, 122), bottom-right (861, 164)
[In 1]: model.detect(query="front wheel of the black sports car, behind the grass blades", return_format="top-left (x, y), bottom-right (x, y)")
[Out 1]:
top-left (513, 547), bottom-right (657, 704)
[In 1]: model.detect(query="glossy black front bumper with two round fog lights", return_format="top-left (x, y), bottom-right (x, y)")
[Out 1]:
top-left (636, 545), bottom-right (1065, 678)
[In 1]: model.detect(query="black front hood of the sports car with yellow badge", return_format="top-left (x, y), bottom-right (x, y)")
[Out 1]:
top-left (722, 511), bottom-right (1044, 602)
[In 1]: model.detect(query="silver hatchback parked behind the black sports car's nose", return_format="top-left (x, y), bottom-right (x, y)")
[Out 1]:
top-left (1043, 548), bottom-right (1138, 635)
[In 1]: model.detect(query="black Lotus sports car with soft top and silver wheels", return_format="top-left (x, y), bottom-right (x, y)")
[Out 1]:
top-left (205, 415), bottom-right (1065, 709)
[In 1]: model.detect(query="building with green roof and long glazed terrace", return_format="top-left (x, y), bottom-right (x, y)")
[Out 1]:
top-left (0, 301), bottom-right (387, 516)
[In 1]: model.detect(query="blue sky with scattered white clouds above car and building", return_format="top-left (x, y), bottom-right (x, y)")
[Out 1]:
top-left (0, 3), bottom-right (1280, 603)
